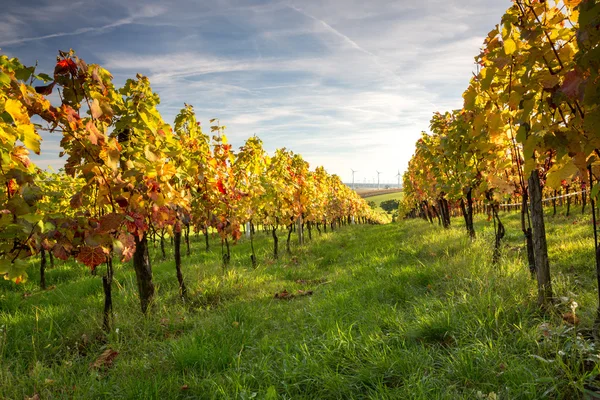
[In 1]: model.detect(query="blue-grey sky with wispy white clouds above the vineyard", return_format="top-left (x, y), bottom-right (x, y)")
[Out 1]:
top-left (0, 0), bottom-right (511, 183)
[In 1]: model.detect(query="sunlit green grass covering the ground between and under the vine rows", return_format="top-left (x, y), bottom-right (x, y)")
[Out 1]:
top-left (0, 206), bottom-right (599, 399)
